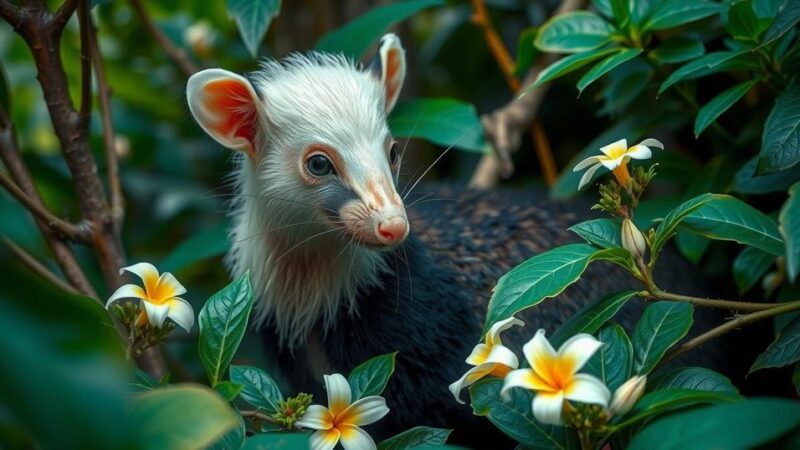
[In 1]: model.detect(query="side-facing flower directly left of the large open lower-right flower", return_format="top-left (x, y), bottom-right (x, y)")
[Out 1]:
top-left (450, 317), bottom-right (525, 404)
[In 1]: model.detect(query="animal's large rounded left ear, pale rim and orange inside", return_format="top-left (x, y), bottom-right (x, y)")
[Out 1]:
top-left (186, 69), bottom-right (260, 158)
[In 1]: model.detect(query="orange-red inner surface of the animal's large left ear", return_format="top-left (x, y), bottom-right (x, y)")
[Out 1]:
top-left (203, 79), bottom-right (257, 152)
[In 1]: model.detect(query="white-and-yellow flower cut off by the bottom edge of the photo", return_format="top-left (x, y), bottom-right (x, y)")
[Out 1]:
top-left (297, 373), bottom-right (389, 450)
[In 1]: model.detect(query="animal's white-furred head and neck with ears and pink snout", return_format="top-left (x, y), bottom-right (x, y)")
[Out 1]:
top-left (187, 34), bottom-right (409, 346)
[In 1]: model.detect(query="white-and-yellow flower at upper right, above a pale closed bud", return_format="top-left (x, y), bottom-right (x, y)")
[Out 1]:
top-left (572, 138), bottom-right (664, 190)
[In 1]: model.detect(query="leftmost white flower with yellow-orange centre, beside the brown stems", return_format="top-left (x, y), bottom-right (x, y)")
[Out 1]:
top-left (106, 263), bottom-right (194, 331)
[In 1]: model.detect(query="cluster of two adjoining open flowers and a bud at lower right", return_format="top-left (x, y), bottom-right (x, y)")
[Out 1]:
top-left (450, 317), bottom-right (646, 425)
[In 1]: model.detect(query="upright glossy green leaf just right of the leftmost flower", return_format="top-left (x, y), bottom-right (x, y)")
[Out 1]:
top-left (198, 274), bottom-right (253, 386)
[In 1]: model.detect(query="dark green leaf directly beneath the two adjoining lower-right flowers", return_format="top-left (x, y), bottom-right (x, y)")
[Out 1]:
top-left (469, 378), bottom-right (580, 450)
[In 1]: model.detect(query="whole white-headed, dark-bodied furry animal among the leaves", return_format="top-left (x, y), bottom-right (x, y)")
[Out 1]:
top-left (187, 34), bottom-right (724, 443)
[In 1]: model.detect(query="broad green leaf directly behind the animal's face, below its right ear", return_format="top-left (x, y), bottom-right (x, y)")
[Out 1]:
top-left (388, 98), bottom-right (486, 153)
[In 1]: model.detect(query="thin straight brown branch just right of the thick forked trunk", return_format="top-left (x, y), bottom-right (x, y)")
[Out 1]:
top-left (89, 15), bottom-right (125, 230)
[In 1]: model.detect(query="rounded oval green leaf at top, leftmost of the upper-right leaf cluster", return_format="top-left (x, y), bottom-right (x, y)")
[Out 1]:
top-left (534, 11), bottom-right (611, 53)
